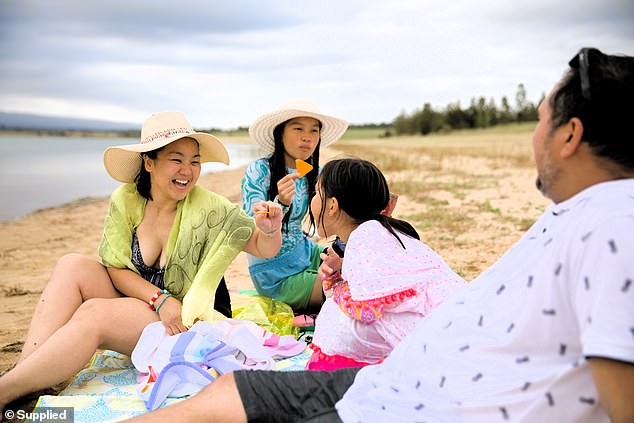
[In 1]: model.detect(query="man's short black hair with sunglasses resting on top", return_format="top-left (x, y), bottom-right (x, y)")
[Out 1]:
top-left (549, 48), bottom-right (634, 170)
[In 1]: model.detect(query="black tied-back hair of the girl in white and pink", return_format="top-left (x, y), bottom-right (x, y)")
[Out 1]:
top-left (319, 158), bottom-right (420, 248)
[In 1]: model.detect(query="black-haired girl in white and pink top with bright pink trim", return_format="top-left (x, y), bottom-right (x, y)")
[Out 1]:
top-left (307, 159), bottom-right (464, 370)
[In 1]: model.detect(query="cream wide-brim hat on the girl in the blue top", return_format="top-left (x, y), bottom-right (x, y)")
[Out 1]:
top-left (249, 99), bottom-right (348, 155)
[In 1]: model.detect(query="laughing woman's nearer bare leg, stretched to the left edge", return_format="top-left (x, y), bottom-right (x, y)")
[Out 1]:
top-left (0, 298), bottom-right (158, 410)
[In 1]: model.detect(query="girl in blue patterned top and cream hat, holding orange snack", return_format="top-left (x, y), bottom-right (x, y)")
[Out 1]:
top-left (242, 100), bottom-right (348, 311)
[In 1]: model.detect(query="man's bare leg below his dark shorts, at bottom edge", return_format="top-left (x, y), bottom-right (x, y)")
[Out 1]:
top-left (130, 373), bottom-right (247, 423)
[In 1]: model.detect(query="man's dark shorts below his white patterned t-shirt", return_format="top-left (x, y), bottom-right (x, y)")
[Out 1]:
top-left (233, 368), bottom-right (359, 423)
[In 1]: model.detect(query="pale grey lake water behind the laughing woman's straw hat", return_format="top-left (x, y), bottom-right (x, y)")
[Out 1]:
top-left (0, 136), bottom-right (258, 221)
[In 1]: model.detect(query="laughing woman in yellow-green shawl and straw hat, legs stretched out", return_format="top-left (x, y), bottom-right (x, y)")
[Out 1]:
top-left (0, 112), bottom-right (282, 409)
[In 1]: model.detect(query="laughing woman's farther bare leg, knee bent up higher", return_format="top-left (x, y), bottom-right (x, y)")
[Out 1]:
top-left (18, 254), bottom-right (121, 363)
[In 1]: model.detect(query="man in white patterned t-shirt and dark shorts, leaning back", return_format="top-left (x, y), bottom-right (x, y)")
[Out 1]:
top-left (130, 49), bottom-right (634, 423)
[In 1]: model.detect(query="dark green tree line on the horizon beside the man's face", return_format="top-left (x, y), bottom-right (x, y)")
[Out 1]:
top-left (393, 84), bottom-right (544, 135)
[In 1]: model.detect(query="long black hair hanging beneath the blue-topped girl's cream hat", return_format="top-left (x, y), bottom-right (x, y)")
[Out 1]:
top-left (267, 119), bottom-right (321, 232)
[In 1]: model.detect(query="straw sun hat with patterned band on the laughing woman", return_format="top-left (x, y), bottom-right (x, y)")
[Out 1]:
top-left (103, 112), bottom-right (229, 183)
